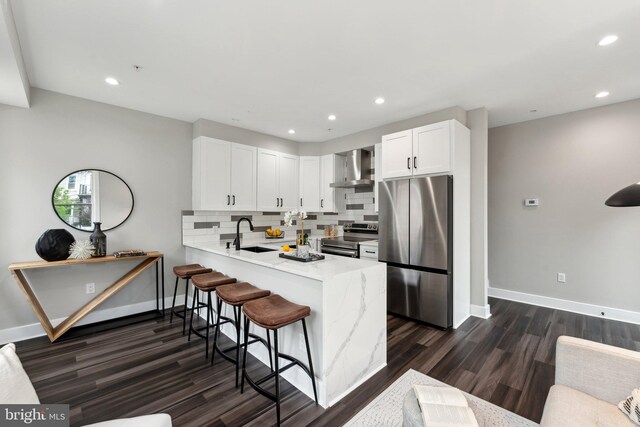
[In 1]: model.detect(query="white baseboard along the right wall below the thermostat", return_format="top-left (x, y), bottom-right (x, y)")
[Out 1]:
top-left (489, 288), bottom-right (640, 325)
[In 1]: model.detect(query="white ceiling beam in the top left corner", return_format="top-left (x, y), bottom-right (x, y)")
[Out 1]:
top-left (0, 0), bottom-right (30, 108)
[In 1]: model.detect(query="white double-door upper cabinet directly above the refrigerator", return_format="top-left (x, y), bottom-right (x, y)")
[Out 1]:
top-left (381, 120), bottom-right (464, 179)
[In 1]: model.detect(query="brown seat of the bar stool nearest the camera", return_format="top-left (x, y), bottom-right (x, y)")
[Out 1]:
top-left (242, 295), bottom-right (311, 329)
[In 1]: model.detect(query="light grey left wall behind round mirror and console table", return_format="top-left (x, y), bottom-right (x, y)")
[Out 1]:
top-left (0, 88), bottom-right (192, 338)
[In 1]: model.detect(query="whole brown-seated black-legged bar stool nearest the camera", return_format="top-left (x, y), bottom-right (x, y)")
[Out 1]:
top-left (240, 295), bottom-right (318, 425)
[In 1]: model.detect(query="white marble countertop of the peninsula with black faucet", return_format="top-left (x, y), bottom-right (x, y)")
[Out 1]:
top-left (184, 239), bottom-right (380, 281)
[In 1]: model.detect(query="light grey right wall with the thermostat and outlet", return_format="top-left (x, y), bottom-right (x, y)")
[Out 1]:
top-left (489, 100), bottom-right (640, 312)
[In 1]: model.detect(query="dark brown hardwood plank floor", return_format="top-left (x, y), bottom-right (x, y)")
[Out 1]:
top-left (17, 299), bottom-right (640, 426)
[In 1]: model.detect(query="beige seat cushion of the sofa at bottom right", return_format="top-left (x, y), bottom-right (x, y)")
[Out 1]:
top-left (540, 384), bottom-right (634, 427)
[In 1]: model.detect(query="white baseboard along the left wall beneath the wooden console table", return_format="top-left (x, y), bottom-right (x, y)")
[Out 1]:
top-left (0, 297), bottom-right (171, 345)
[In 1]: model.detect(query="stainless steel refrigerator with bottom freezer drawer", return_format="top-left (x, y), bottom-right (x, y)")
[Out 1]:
top-left (378, 175), bottom-right (453, 328)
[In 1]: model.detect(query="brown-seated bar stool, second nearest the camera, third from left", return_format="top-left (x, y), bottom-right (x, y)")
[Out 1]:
top-left (211, 282), bottom-right (273, 387)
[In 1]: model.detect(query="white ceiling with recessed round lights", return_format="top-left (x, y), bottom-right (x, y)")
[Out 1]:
top-left (6, 0), bottom-right (640, 141)
